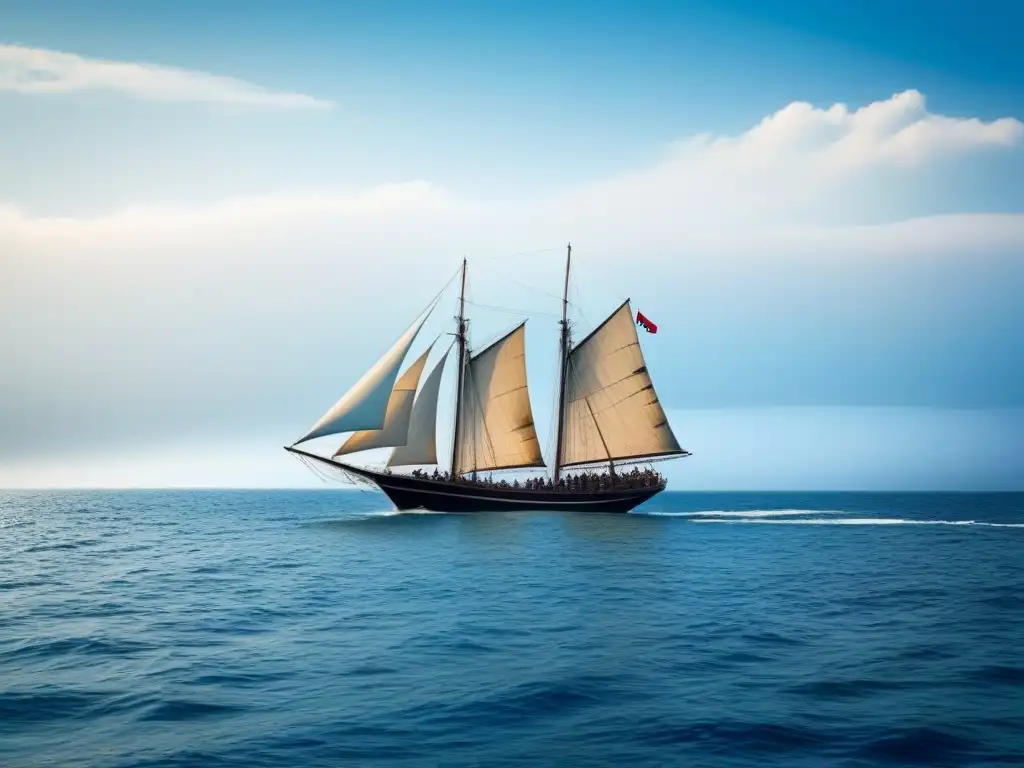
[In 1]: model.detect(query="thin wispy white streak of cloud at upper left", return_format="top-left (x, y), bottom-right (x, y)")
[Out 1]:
top-left (0, 44), bottom-right (331, 109)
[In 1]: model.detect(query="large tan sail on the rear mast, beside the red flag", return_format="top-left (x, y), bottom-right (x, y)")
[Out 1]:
top-left (560, 300), bottom-right (685, 467)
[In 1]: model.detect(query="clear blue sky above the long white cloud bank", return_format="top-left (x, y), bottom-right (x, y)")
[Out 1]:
top-left (4, 2), bottom-right (1024, 210)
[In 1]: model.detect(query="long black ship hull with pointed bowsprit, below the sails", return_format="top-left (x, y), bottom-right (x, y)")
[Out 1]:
top-left (286, 447), bottom-right (665, 513)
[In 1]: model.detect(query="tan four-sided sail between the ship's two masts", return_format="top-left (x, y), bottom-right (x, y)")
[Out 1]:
top-left (454, 323), bottom-right (544, 474)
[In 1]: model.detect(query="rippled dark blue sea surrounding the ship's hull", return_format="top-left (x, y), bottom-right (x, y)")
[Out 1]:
top-left (0, 492), bottom-right (1024, 768)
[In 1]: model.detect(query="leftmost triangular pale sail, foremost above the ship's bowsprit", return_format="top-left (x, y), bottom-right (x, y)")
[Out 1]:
top-left (294, 299), bottom-right (437, 445)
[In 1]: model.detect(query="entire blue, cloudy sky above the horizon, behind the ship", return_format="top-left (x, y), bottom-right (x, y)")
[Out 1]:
top-left (0, 0), bottom-right (1024, 489)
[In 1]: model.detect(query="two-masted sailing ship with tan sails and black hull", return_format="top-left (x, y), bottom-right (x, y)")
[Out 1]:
top-left (285, 245), bottom-right (690, 512)
